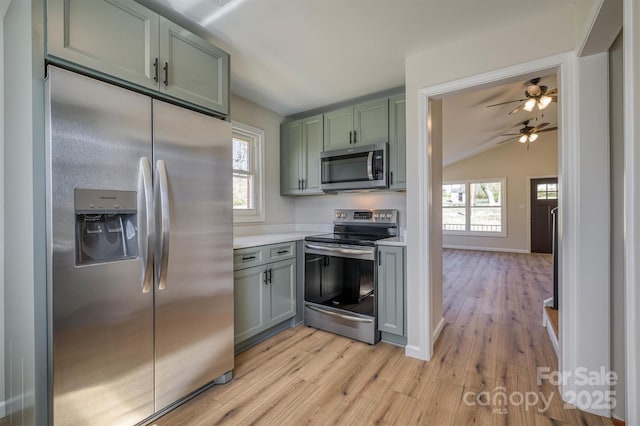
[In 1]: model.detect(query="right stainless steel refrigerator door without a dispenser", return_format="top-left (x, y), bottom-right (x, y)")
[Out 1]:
top-left (153, 100), bottom-right (233, 411)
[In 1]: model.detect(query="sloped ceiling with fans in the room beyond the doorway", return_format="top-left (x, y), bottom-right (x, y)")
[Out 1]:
top-left (442, 73), bottom-right (562, 166)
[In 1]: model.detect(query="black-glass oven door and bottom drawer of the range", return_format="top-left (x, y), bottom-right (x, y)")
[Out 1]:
top-left (304, 241), bottom-right (380, 344)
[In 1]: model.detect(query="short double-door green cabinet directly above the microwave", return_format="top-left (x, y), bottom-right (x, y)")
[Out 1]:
top-left (324, 98), bottom-right (389, 151)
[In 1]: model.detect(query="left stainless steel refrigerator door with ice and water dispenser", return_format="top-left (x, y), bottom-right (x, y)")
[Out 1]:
top-left (46, 67), bottom-right (154, 425)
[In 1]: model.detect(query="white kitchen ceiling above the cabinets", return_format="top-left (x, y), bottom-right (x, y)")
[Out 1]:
top-left (145, 0), bottom-right (574, 115)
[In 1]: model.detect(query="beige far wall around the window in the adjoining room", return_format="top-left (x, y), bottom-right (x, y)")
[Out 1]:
top-left (442, 133), bottom-right (558, 252)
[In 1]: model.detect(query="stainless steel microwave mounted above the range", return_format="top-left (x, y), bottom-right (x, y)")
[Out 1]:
top-left (320, 143), bottom-right (389, 192)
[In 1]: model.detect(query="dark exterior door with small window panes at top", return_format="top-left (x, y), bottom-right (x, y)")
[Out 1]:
top-left (531, 178), bottom-right (558, 253)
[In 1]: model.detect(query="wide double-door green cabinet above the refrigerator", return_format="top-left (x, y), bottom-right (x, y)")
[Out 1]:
top-left (46, 0), bottom-right (229, 115)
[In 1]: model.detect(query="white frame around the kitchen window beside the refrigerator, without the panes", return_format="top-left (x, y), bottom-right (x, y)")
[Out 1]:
top-left (231, 120), bottom-right (265, 223)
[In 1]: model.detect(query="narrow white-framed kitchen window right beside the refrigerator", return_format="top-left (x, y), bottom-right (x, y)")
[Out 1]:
top-left (233, 122), bottom-right (264, 222)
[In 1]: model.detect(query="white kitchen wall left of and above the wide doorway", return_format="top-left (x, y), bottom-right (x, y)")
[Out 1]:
top-left (405, 3), bottom-right (575, 356)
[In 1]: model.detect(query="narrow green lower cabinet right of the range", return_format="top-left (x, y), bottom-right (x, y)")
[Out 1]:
top-left (377, 246), bottom-right (405, 336)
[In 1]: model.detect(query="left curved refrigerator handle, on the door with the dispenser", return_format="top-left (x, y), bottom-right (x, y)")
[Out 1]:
top-left (139, 157), bottom-right (155, 293)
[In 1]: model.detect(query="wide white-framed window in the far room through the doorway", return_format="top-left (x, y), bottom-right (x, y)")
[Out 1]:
top-left (442, 178), bottom-right (507, 237)
